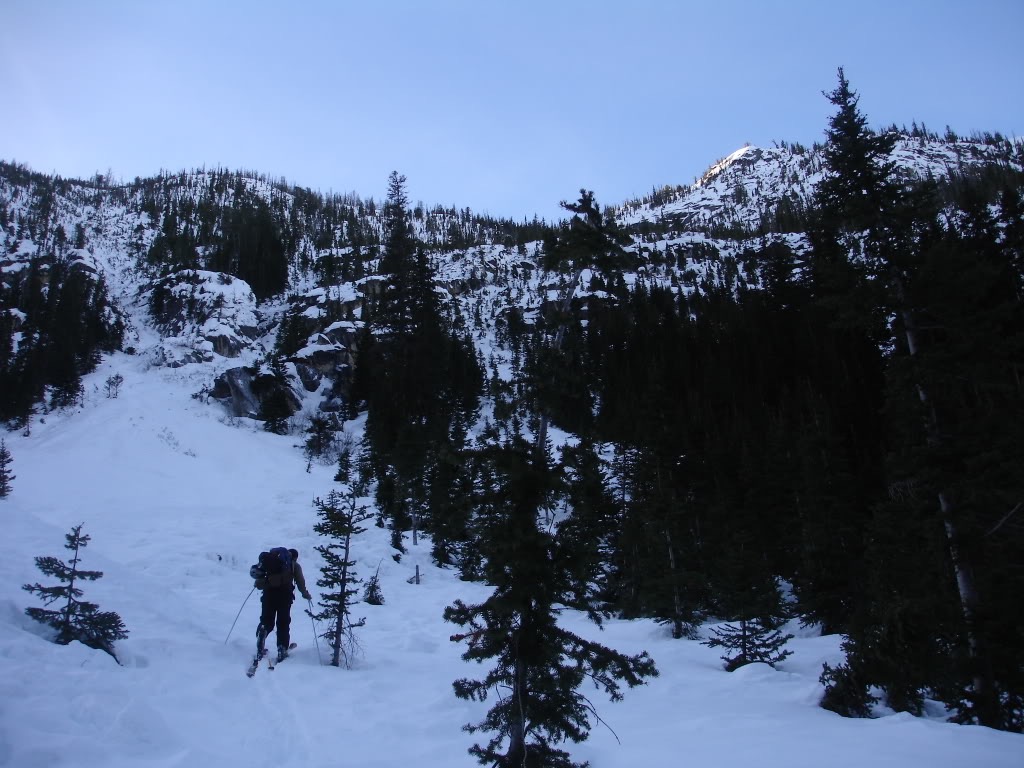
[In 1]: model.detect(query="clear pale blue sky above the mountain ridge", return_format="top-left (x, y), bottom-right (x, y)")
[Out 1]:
top-left (0, 0), bottom-right (1024, 220)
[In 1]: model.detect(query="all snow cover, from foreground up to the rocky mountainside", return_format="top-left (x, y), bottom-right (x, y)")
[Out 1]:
top-left (0, 141), bottom-right (1024, 768)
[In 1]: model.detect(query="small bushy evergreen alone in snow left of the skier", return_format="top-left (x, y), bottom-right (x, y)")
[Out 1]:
top-left (22, 524), bottom-right (128, 659)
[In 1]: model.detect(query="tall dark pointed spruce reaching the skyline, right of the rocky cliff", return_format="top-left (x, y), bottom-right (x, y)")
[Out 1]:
top-left (362, 172), bottom-right (482, 558)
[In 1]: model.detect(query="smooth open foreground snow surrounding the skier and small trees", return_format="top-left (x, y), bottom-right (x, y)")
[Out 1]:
top-left (0, 354), bottom-right (1024, 768)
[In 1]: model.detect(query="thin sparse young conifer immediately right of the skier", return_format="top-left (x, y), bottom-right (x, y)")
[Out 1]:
top-left (313, 489), bottom-right (371, 667)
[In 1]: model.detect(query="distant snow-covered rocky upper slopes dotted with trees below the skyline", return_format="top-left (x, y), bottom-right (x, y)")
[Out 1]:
top-left (0, 135), bottom-right (1024, 391)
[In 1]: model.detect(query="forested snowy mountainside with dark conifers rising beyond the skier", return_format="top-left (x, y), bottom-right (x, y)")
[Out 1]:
top-left (0, 71), bottom-right (1024, 765)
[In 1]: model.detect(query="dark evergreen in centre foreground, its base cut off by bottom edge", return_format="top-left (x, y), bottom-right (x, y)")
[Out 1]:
top-left (444, 437), bottom-right (657, 768)
